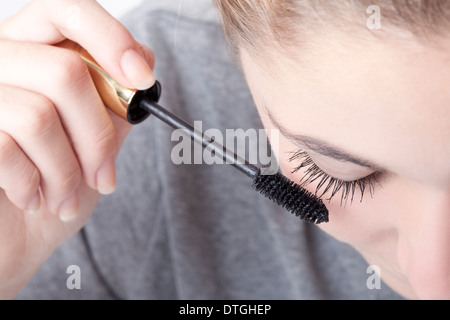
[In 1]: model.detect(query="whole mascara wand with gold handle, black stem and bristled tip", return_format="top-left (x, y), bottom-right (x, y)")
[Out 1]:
top-left (63, 40), bottom-right (328, 224)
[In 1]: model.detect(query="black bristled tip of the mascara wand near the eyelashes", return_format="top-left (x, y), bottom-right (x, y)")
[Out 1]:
top-left (253, 173), bottom-right (328, 224)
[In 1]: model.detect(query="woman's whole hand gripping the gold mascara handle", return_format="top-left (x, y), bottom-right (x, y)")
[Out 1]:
top-left (0, 0), bottom-right (155, 298)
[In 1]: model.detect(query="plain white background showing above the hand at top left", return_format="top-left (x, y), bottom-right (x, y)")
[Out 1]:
top-left (0, 0), bottom-right (142, 21)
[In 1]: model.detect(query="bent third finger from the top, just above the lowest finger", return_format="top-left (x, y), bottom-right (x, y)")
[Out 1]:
top-left (0, 85), bottom-right (82, 215)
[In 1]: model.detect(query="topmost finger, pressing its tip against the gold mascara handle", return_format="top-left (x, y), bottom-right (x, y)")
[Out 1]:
top-left (0, 0), bottom-right (155, 90)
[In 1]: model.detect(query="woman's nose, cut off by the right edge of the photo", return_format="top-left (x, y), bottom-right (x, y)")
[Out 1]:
top-left (397, 188), bottom-right (450, 299)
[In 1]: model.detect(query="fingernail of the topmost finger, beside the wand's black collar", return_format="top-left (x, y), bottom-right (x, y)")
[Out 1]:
top-left (120, 49), bottom-right (155, 90)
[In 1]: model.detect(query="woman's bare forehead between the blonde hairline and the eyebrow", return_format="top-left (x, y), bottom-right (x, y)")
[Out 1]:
top-left (242, 41), bottom-right (450, 186)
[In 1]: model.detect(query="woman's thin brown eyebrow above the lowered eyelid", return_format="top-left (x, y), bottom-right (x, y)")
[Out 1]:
top-left (264, 106), bottom-right (382, 171)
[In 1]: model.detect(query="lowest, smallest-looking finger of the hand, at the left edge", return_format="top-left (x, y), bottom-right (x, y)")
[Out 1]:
top-left (0, 131), bottom-right (41, 213)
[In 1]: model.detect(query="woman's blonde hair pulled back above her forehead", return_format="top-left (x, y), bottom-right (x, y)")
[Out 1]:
top-left (214, 0), bottom-right (450, 59)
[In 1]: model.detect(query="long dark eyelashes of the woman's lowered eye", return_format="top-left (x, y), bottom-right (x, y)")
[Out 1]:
top-left (289, 150), bottom-right (381, 206)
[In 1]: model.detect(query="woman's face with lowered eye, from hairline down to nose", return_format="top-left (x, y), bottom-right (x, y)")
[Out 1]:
top-left (241, 40), bottom-right (450, 299)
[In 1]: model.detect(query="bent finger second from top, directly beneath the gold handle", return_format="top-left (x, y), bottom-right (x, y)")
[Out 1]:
top-left (0, 40), bottom-right (118, 193)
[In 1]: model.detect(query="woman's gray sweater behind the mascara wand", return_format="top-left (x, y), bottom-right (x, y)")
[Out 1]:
top-left (18, 5), bottom-right (399, 299)
